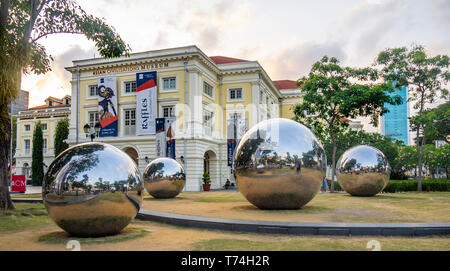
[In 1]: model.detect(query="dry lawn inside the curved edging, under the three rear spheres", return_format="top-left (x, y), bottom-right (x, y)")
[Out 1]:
top-left (143, 192), bottom-right (450, 223)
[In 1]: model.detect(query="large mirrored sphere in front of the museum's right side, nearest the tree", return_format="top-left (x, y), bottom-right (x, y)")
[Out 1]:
top-left (233, 118), bottom-right (327, 209)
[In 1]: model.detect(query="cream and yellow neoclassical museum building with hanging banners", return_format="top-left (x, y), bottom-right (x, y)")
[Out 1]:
top-left (66, 46), bottom-right (301, 191)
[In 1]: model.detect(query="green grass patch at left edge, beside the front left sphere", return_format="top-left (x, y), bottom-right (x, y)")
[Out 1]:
top-left (0, 203), bottom-right (53, 232)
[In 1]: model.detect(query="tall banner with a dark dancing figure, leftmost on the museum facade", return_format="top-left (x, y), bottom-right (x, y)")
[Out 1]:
top-left (97, 76), bottom-right (118, 137)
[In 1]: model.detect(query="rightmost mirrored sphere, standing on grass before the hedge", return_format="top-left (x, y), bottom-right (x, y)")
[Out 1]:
top-left (336, 145), bottom-right (391, 196)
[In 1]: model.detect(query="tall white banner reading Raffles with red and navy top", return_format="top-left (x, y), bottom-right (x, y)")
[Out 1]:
top-left (136, 71), bottom-right (158, 135)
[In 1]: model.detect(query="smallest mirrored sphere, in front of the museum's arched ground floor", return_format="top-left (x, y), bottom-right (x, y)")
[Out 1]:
top-left (144, 158), bottom-right (186, 199)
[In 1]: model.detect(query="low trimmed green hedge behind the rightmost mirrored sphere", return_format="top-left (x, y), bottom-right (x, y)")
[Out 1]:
top-left (328, 179), bottom-right (450, 193)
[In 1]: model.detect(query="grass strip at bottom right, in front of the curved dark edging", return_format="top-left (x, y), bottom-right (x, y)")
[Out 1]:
top-left (194, 235), bottom-right (450, 254)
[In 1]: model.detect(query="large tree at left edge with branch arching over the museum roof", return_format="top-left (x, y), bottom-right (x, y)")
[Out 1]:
top-left (0, 0), bottom-right (130, 209)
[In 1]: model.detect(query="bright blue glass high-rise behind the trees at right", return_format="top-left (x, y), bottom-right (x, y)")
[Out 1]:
top-left (378, 86), bottom-right (411, 145)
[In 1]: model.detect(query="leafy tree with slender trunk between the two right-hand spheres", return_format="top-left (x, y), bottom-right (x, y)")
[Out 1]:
top-left (294, 56), bottom-right (402, 192)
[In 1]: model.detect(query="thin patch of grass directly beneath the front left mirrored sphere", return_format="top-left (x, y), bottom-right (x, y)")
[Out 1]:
top-left (38, 228), bottom-right (149, 244)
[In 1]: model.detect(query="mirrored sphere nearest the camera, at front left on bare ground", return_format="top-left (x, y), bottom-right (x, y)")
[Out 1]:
top-left (42, 143), bottom-right (144, 236)
